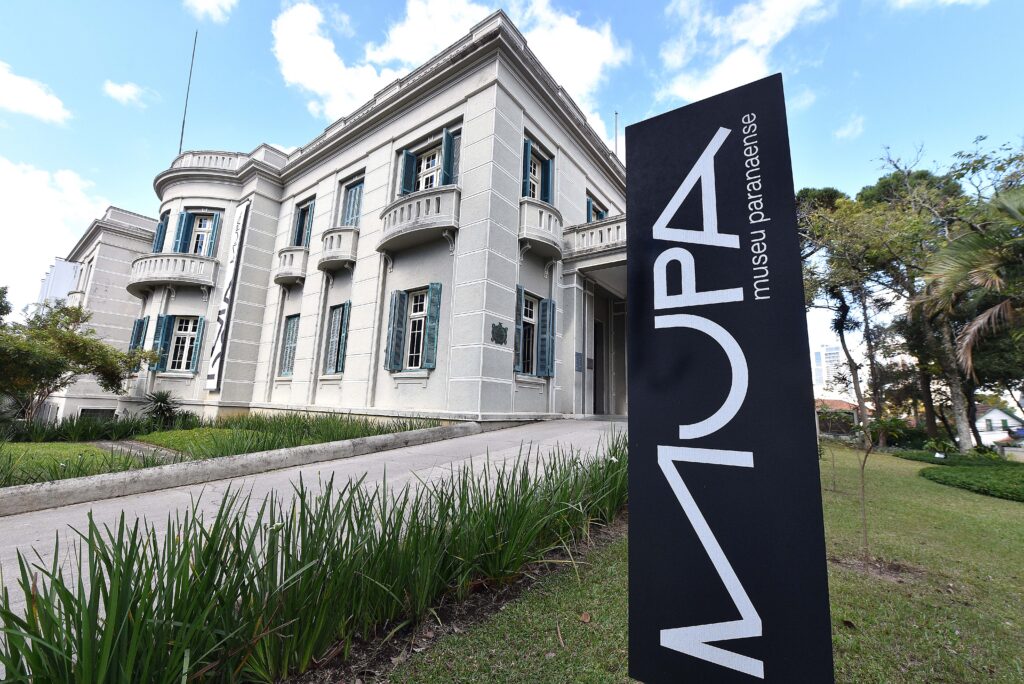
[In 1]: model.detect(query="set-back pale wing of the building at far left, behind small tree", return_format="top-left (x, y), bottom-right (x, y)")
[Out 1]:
top-left (40, 207), bottom-right (157, 419)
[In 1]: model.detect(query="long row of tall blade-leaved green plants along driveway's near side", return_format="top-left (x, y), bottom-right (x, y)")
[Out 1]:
top-left (0, 434), bottom-right (627, 684)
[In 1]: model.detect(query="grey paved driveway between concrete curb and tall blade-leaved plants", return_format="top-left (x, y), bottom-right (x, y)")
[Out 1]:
top-left (0, 420), bottom-right (626, 608)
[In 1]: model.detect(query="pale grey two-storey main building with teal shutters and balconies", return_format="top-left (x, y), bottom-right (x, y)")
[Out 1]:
top-left (64, 12), bottom-right (626, 420)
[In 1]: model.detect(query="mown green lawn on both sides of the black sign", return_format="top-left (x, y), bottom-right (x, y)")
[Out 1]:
top-left (390, 447), bottom-right (1024, 684)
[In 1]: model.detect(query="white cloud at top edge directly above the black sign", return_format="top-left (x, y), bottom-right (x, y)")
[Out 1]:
top-left (657, 0), bottom-right (835, 101)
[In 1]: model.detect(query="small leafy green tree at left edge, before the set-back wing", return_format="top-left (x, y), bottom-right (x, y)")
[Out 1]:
top-left (0, 300), bottom-right (155, 420)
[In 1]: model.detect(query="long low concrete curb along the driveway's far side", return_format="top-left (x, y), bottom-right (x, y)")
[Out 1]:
top-left (0, 423), bottom-right (518, 517)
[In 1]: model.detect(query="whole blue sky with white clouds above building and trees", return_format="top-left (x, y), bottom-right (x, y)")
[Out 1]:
top-left (0, 0), bottom-right (1024, 321)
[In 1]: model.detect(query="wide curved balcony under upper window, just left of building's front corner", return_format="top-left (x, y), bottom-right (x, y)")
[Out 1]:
top-left (377, 185), bottom-right (460, 252)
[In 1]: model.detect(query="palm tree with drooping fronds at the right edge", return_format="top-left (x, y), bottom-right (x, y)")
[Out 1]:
top-left (924, 188), bottom-right (1024, 373)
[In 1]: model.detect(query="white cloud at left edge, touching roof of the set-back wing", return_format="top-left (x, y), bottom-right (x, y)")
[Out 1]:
top-left (0, 157), bottom-right (111, 312)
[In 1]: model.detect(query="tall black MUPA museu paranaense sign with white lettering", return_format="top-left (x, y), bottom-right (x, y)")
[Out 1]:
top-left (626, 75), bottom-right (834, 684)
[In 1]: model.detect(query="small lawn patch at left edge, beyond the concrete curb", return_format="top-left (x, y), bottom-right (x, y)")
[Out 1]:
top-left (0, 441), bottom-right (146, 487)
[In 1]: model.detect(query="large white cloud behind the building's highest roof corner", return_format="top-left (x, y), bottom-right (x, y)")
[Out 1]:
top-left (272, 0), bottom-right (630, 148)
